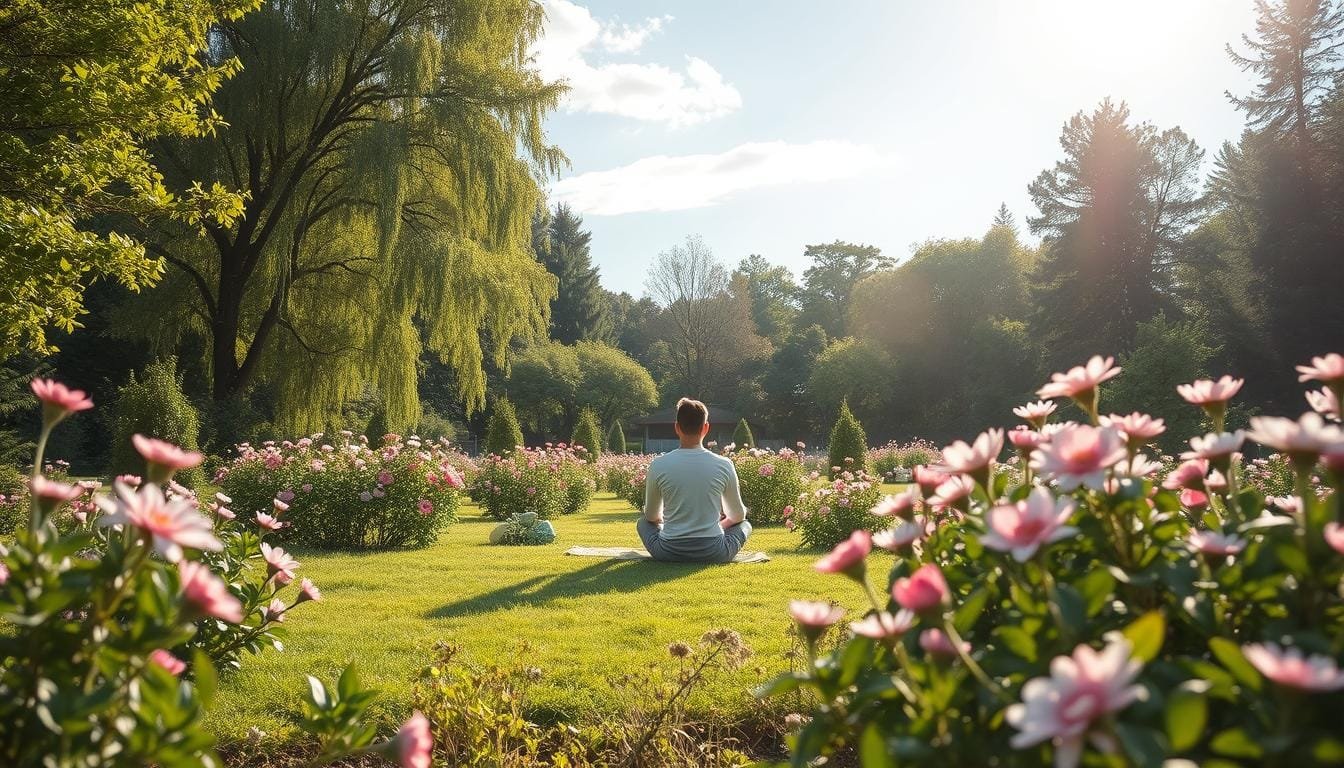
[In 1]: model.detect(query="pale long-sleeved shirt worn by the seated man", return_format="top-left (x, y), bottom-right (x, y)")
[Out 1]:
top-left (644, 448), bottom-right (747, 538)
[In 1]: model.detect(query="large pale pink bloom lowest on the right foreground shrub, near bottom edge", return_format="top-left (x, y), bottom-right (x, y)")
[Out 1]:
top-left (1007, 636), bottom-right (1144, 768)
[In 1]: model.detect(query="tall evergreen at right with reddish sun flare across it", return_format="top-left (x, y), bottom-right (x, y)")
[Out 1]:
top-left (1028, 100), bottom-right (1203, 366)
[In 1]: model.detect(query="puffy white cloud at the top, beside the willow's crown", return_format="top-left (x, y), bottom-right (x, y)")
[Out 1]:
top-left (532, 0), bottom-right (742, 128)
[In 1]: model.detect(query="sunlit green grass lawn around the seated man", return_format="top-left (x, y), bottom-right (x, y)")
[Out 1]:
top-left (210, 495), bottom-right (866, 742)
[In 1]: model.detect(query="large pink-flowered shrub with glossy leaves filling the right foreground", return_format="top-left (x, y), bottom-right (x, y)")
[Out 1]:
top-left (762, 355), bottom-right (1344, 768)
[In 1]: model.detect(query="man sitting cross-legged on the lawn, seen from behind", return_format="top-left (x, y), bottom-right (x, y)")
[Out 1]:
top-left (638, 397), bottom-right (751, 562)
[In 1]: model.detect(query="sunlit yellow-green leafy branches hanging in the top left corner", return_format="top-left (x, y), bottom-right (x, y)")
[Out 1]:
top-left (0, 0), bottom-right (258, 358)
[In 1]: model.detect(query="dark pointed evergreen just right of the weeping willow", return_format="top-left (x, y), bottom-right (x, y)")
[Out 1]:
top-left (538, 203), bottom-right (612, 344)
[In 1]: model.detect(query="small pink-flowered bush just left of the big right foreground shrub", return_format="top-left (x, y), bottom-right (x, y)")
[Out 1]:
top-left (782, 472), bottom-right (888, 549)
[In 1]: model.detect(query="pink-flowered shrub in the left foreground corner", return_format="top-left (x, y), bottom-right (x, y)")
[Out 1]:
top-left (0, 379), bottom-right (429, 767)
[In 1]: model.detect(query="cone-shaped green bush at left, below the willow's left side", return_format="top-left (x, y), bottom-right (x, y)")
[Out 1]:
top-left (109, 358), bottom-right (206, 488)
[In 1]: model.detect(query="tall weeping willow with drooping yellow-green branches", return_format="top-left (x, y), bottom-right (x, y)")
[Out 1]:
top-left (140, 0), bottom-right (563, 432)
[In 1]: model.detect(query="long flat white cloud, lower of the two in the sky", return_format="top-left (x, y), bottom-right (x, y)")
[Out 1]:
top-left (551, 141), bottom-right (895, 215)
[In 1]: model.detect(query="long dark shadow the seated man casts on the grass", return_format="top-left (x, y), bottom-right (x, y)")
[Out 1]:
top-left (425, 560), bottom-right (723, 619)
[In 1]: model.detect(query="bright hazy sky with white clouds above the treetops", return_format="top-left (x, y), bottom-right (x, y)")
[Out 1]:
top-left (535, 0), bottom-right (1253, 296)
